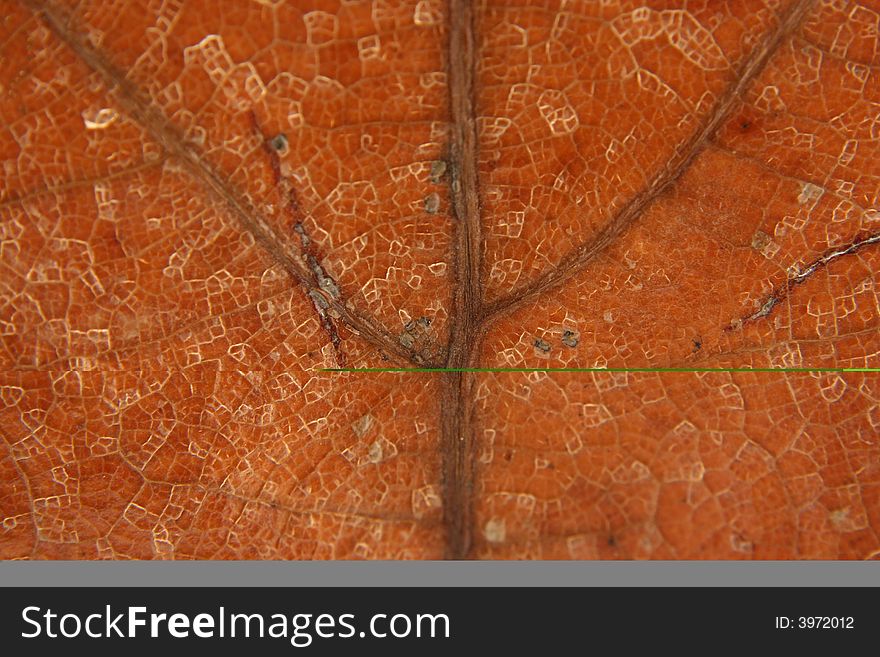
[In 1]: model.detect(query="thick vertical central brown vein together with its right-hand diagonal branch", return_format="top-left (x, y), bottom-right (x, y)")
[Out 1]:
top-left (441, 0), bottom-right (813, 559)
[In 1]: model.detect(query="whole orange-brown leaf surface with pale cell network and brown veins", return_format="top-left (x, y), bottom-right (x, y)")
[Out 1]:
top-left (0, 0), bottom-right (880, 559)
